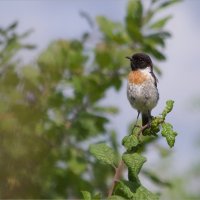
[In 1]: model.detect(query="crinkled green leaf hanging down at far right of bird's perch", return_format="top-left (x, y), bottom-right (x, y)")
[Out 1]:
top-left (161, 123), bottom-right (177, 147)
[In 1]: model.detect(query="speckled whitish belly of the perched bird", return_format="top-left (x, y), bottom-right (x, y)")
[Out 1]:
top-left (127, 81), bottom-right (159, 113)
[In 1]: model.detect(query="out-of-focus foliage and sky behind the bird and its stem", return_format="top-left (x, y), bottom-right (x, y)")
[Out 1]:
top-left (0, 0), bottom-right (200, 199)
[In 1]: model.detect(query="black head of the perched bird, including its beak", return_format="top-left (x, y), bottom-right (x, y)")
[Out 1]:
top-left (126, 53), bottom-right (153, 70)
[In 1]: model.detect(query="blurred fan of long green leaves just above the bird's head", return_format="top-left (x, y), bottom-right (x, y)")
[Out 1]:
top-left (123, 0), bottom-right (179, 60)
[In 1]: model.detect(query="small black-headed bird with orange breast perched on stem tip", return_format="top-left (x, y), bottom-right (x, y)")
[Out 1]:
top-left (126, 53), bottom-right (159, 130)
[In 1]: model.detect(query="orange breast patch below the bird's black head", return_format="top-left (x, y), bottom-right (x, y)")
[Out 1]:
top-left (128, 70), bottom-right (147, 85)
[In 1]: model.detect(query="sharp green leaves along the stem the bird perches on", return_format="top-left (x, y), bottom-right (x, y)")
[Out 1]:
top-left (87, 100), bottom-right (176, 200)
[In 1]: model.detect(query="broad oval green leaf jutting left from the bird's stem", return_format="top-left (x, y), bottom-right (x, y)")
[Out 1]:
top-left (90, 143), bottom-right (118, 166)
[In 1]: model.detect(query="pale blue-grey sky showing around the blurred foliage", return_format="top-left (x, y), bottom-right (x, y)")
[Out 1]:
top-left (0, 0), bottom-right (200, 176)
